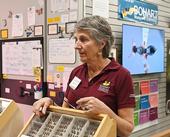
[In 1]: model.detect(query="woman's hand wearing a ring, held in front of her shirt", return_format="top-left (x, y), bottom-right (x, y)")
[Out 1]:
top-left (76, 97), bottom-right (109, 114)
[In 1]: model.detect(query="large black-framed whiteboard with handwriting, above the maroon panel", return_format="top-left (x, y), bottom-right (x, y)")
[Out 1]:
top-left (0, 37), bottom-right (43, 76)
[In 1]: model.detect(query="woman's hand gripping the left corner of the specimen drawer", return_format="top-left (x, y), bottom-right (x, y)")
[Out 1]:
top-left (33, 97), bottom-right (53, 116)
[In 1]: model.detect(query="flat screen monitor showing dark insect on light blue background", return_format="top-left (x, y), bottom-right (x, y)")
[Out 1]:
top-left (122, 24), bottom-right (165, 75)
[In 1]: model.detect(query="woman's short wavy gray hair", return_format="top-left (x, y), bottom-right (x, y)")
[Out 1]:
top-left (74, 16), bottom-right (114, 58)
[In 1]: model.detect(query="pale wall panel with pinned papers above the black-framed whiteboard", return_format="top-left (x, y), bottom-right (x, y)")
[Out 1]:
top-left (0, 0), bottom-right (45, 39)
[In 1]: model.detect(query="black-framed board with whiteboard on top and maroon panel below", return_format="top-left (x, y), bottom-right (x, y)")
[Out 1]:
top-left (0, 37), bottom-right (46, 105)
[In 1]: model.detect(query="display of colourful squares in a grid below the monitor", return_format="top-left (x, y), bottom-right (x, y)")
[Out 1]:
top-left (133, 79), bottom-right (158, 132)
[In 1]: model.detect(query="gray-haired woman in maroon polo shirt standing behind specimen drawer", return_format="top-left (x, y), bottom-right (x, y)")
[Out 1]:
top-left (33, 16), bottom-right (135, 137)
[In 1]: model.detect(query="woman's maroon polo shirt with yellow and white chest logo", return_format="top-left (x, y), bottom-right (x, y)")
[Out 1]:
top-left (66, 59), bottom-right (135, 114)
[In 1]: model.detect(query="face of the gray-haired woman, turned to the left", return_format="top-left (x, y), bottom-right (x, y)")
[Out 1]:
top-left (74, 30), bottom-right (100, 63)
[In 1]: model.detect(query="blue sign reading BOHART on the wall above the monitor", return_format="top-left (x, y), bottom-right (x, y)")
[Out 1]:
top-left (118, 0), bottom-right (158, 25)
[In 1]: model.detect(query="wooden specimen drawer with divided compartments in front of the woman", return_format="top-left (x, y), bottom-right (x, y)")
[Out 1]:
top-left (18, 106), bottom-right (116, 137)
